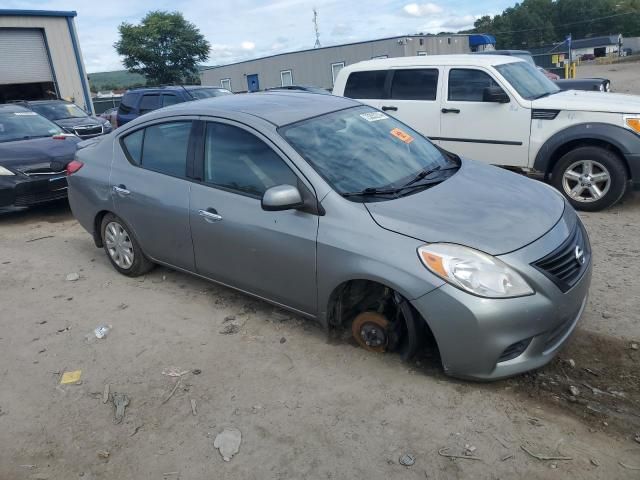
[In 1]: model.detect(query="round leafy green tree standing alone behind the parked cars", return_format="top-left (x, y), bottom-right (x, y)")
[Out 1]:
top-left (114, 10), bottom-right (210, 84)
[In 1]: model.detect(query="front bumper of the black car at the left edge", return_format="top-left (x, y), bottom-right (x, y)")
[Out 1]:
top-left (0, 173), bottom-right (67, 207)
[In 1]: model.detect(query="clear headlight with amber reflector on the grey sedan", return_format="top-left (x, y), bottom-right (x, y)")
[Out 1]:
top-left (418, 243), bottom-right (534, 298)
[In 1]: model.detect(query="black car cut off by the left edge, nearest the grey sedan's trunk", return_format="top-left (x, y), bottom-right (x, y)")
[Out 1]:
top-left (0, 105), bottom-right (80, 209)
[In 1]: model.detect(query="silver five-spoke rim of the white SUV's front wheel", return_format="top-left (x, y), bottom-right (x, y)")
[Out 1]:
top-left (562, 160), bottom-right (611, 203)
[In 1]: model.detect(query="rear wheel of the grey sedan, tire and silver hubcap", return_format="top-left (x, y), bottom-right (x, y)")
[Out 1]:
top-left (100, 213), bottom-right (154, 277)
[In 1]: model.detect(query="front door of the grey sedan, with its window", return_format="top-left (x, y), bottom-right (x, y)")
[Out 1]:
top-left (190, 121), bottom-right (318, 315)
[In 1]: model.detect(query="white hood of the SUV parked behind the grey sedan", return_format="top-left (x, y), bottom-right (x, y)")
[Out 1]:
top-left (531, 90), bottom-right (640, 113)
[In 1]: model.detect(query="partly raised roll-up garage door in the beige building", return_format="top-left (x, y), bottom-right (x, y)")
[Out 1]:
top-left (0, 28), bottom-right (53, 85)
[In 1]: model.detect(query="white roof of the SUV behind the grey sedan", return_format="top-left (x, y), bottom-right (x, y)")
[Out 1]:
top-left (344, 54), bottom-right (523, 71)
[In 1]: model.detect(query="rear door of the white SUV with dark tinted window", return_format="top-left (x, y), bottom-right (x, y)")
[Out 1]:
top-left (381, 68), bottom-right (440, 142)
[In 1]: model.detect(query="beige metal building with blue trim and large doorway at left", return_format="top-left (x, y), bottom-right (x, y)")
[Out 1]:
top-left (0, 9), bottom-right (93, 112)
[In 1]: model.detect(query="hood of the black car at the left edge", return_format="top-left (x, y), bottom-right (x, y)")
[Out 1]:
top-left (0, 136), bottom-right (80, 171)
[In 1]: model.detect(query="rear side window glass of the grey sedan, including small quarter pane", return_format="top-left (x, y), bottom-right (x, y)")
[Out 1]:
top-left (122, 121), bottom-right (191, 178)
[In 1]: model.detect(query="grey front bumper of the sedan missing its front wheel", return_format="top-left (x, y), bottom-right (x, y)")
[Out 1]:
top-left (412, 207), bottom-right (592, 380)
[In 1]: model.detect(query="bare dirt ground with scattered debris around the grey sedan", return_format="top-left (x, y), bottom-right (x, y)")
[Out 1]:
top-left (0, 189), bottom-right (640, 480)
